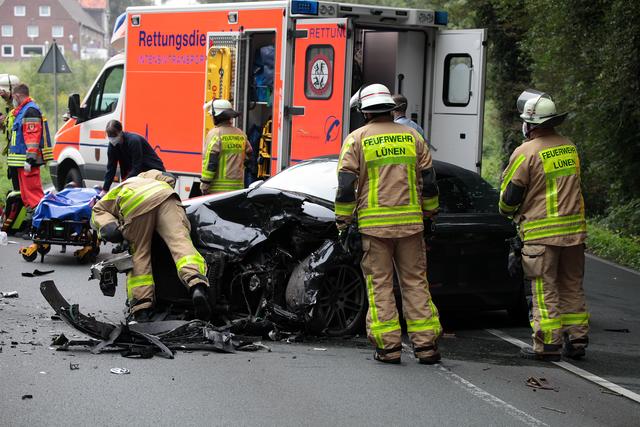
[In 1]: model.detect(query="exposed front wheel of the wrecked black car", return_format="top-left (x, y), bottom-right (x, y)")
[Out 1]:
top-left (314, 265), bottom-right (367, 336)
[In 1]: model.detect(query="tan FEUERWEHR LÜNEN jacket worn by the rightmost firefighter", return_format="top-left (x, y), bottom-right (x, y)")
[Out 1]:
top-left (499, 130), bottom-right (587, 246)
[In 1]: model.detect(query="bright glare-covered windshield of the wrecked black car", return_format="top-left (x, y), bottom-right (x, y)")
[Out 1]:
top-left (262, 161), bottom-right (338, 203)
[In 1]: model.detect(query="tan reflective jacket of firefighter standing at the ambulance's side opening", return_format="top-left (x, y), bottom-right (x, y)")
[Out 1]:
top-left (201, 125), bottom-right (253, 193)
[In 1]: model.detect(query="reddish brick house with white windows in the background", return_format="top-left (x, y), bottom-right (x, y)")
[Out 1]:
top-left (0, 0), bottom-right (108, 61)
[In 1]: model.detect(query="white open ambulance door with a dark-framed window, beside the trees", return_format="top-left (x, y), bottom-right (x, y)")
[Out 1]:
top-left (428, 29), bottom-right (486, 173)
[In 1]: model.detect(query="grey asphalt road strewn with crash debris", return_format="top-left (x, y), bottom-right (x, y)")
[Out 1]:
top-left (0, 239), bottom-right (640, 426)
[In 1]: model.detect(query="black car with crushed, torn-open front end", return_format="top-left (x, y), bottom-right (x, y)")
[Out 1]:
top-left (153, 158), bottom-right (523, 335)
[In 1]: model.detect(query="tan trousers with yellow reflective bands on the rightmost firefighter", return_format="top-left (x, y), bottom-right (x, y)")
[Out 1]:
top-left (522, 244), bottom-right (589, 354)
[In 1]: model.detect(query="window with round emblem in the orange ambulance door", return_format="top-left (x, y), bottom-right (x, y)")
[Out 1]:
top-left (304, 44), bottom-right (334, 99)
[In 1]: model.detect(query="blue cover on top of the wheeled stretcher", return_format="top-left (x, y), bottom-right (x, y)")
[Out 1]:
top-left (33, 188), bottom-right (98, 230)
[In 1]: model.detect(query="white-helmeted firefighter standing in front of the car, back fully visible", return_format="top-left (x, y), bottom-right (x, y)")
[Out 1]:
top-left (335, 84), bottom-right (442, 364)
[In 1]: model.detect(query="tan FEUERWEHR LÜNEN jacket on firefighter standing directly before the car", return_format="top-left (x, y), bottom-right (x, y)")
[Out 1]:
top-left (335, 117), bottom-right (438, 237)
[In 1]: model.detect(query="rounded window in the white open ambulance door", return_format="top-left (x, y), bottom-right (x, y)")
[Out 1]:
top-left (442, 53), bottom-right (473, 107)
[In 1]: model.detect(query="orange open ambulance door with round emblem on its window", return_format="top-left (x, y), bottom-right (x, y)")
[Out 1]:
top-left (288, 19), bottom-right (350, 167)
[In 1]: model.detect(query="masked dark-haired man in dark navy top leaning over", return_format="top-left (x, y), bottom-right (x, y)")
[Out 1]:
top-left (102, 120), bottom-right (165, 193)
